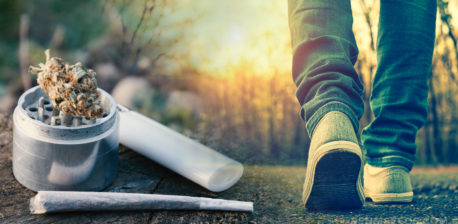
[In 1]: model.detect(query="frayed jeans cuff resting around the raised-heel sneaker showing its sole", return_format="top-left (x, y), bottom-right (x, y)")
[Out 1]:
top-left (305, 101), bottom-right (359, 137)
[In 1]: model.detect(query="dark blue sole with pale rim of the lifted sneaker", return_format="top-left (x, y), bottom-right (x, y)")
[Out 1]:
top-left (303, 141), bottom-right (365, 210)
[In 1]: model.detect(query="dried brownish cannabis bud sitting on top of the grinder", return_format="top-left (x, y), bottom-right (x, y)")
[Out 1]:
top-left (29, 49), bottom-right (103, 118)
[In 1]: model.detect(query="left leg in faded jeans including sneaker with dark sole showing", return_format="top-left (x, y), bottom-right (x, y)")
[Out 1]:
top-left (289, 0), bottom-right (364, 209)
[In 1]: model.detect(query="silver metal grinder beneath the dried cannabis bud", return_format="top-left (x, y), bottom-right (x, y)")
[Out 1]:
top-left (13, 86), bottom-right (119, 191)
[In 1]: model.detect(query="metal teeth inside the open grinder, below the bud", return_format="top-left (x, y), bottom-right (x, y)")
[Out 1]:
top-left (26, 96), bottom-right (106, 127)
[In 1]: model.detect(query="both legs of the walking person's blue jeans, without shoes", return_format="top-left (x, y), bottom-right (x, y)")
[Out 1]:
top-left (289, 0), bottom-right (436, 169)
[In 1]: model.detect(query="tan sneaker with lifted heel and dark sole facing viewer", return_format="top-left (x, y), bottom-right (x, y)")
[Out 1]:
top-left (302, 112), bottom-right (365, 210)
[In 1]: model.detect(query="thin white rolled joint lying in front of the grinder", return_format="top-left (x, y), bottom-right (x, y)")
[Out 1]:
top-left (29, 191), bottom-right (253, 214)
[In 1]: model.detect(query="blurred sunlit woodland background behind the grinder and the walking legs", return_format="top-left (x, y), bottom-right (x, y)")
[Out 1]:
top-left (0, 0), bottom-right (458, 165)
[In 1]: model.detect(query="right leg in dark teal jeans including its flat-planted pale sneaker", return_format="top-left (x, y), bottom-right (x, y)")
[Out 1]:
top-left (361, 0), bottom-right (436, 202)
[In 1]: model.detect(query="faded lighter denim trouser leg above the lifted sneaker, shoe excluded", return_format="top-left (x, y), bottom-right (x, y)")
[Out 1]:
top-left (288, 0), bottom-right (364, 136)
